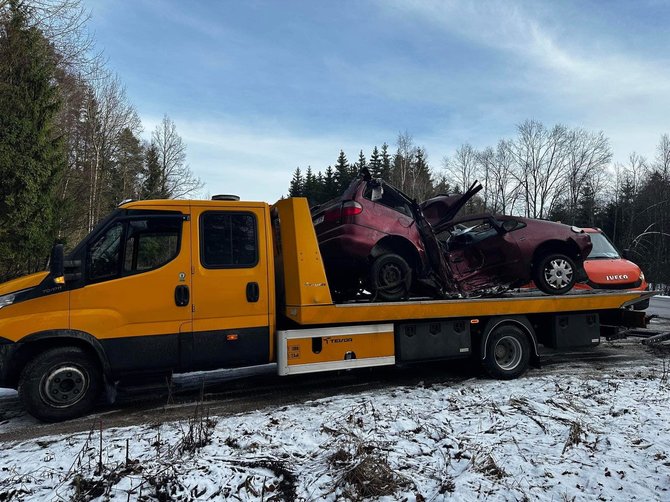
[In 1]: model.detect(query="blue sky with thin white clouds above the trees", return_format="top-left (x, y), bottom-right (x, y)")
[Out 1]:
top-left (86, 0), bottom-right (670, 202)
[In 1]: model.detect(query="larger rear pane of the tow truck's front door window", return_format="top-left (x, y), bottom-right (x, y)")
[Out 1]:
top-left (123, 218), bottom-right (181, 275)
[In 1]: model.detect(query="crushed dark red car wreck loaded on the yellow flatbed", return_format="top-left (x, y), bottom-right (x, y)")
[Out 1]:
top-left (312, 170), bottom-right (591, 301)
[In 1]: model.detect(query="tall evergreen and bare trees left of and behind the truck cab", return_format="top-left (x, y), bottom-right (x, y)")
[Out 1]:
top-left (0, 0), bottom-right (201, 280)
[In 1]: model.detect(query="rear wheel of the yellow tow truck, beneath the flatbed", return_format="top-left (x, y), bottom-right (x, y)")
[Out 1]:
top-left (484, 324), bottom-right (530, 380)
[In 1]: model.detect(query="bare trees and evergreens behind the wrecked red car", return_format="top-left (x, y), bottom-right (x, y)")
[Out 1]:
top-left (288, 120), bottom-right (670, 284)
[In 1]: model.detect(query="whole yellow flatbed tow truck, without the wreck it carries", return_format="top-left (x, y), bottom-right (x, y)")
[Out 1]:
top-left (0, 198), bottom-right (653, 421)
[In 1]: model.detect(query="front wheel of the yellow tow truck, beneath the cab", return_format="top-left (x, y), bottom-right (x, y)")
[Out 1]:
top-left (19, 347), bottom-right (102, 422)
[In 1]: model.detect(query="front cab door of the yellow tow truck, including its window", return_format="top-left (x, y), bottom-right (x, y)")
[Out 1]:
top-left (70, 206), bottom-right (191, 374)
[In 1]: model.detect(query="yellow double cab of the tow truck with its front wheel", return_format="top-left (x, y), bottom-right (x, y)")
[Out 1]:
top-left (0, 200), bottom-right (275, 420)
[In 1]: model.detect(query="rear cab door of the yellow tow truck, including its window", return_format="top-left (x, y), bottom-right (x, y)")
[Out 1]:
top-left (191, 203), bottom-right (271, 369)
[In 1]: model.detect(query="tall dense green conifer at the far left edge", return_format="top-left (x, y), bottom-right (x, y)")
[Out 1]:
top-left (0, 0), bottom-right (66, 280)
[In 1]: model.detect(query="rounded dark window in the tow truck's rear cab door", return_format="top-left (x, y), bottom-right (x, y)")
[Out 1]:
top-left (200, 211), bottom-right (258, 268)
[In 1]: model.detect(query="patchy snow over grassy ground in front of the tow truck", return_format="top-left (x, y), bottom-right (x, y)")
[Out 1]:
top-left (0, 357), bottom-right (670, 501)
